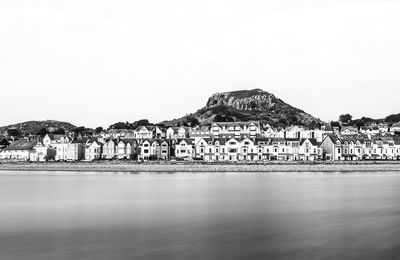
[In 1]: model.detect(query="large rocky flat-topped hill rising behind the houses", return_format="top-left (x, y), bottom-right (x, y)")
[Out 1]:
top-left (162, 89), bottom-right (323, 126)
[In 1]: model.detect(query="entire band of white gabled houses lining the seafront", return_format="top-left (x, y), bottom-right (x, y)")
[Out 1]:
top-left (0, 122), bottom-right (400, 161)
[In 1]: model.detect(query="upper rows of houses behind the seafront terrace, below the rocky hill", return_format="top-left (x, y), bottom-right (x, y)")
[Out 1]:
top-left (99, 121), bottom-right (400, 142)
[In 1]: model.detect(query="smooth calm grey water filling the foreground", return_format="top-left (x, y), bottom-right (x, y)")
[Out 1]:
top-left (0, 172), bottom-right (400, 260)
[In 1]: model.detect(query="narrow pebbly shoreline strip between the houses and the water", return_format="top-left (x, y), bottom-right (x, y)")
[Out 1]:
top-left (0, 161), bottom-right (400, 173)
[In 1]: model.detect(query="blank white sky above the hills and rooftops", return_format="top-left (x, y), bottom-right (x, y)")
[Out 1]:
top-left (0, 0), bottom-right (400, 127)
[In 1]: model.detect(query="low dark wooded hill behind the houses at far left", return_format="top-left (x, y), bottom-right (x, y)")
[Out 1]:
top-left (0, 120), bottom-right (76, 135)
